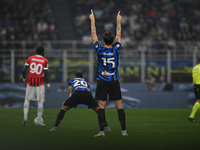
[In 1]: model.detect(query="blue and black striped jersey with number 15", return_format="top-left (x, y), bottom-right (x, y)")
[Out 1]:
top-left (94, 42), bottom-right (121, 81)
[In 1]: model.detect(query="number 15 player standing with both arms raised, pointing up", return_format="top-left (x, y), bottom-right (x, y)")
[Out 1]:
top-left (89, 9), bottom-right (128, 137)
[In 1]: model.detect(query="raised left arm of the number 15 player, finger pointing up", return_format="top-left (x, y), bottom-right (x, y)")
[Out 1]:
top-left (89, 9), bottom-right (98, 44)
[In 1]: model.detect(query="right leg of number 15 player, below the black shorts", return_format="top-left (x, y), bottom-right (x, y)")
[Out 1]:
top-left (115, 100), bottom-right (128, 136)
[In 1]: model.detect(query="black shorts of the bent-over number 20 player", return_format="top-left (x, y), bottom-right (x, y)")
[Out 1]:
top-left (64, 91), bottom-right (98, 108)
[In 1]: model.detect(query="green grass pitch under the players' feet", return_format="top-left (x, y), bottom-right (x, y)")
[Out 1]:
top-left (0, 109), bottom-right (200, 150)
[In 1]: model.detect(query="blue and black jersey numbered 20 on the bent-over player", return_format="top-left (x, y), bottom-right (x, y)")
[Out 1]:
top-left (67, 78), bottom-right (90, 93)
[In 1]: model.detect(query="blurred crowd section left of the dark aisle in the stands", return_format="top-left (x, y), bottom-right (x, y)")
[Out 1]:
top-left (0, 0), bottom-right (59, 49)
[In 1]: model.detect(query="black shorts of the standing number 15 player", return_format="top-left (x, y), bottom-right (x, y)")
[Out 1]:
top-left (95, 80), bottom-right (122, 101)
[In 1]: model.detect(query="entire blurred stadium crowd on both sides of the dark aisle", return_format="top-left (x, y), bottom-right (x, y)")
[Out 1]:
top-left (0, 0), bottom-right (200, 51)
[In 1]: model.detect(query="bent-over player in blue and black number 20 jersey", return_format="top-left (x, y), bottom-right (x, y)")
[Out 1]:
top-left (50, 72), bottom-right (110, 131)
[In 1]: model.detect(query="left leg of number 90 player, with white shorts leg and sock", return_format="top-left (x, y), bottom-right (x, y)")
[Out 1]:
top-left (22, 85), bottom-right (35, 125)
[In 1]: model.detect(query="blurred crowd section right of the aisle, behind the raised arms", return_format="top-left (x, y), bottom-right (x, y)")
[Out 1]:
top-left (73, 0), bottom-right (200, 45)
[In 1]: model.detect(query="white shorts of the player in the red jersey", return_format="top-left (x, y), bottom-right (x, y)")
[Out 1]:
top-left (25, 84), bottom-right (45, 102)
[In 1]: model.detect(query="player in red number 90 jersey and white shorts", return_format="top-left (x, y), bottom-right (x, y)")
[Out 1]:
top-left (22, 46), bottom-right (50, 125)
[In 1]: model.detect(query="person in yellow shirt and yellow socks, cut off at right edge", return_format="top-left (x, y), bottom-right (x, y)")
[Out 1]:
top-left (188, 58), bottom-right (200, 122)
